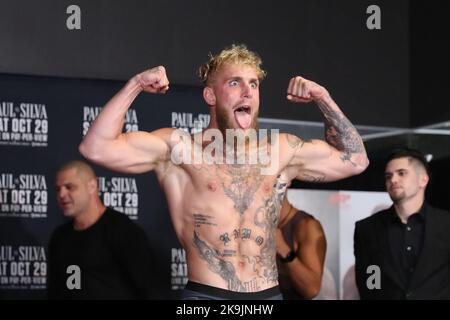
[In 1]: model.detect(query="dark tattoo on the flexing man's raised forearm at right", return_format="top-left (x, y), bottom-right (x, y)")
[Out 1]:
top-left (318, 102), bottom-right (364, 166)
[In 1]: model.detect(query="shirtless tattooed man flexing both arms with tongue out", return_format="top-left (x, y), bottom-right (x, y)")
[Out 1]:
top-left (79, 45), bottom-right (369, 299)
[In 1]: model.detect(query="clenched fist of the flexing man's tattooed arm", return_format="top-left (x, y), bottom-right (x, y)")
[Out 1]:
top-left (287, 76), bottom-right (329, 103)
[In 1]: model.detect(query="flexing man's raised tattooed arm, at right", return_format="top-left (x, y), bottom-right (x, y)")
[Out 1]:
top-left (284, 77), bottom-right (369, 182)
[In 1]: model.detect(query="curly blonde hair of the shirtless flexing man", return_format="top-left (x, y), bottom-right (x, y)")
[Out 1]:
top-left (198, 44), bottom-right (266, 85)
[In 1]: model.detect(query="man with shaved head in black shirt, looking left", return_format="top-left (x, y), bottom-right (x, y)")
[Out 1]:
top-left (48, 161), bottom-right (152, 300)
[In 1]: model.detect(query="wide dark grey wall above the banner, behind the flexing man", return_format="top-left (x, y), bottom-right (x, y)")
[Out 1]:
top-left (0, 0), bottom-right (410, 127)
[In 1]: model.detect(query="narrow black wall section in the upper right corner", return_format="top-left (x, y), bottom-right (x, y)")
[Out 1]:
top-left (410, 0), bottom-right (450, 127)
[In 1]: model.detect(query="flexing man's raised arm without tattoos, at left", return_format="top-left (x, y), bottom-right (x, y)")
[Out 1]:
top-left (79, 67), bottom-right (173, 173)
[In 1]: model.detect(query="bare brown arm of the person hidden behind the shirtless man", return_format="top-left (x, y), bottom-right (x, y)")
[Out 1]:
top-left (277, 216), bottom-right (327, 299)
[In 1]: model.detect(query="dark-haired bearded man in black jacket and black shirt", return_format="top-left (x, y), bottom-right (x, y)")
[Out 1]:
top-left (354, 149), bottom-right (450, 299)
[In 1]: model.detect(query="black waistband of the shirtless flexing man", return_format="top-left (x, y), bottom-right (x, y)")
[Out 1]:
top-left (186, 280), bottom-right (281, 300)
